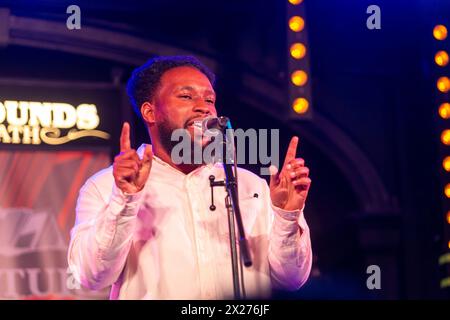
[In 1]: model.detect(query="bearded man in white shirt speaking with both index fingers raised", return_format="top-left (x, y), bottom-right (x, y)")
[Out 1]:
top-left (68, 56), bottom-right (312, 299)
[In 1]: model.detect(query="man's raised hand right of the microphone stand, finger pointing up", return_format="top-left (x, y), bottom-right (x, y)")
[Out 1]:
top-left (270, 137), bottom-right (311, 211)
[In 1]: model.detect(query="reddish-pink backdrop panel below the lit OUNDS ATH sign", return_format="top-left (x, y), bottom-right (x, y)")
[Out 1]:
top-left (0, 151), bottom-right (110, 299)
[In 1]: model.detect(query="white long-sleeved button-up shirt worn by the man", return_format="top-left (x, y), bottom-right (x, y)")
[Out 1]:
top-left (68, 146), bottom-right (312, 299)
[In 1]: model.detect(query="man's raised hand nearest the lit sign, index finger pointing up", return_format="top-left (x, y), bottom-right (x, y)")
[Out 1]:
top-left (113, 122), bottom-right (153, 194)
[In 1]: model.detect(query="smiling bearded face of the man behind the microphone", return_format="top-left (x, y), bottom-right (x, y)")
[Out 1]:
top-left (154, 66), bottom-right (217, 151)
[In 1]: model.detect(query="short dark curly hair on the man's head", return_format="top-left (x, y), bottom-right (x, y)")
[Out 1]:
top-left (127, 56), bottom-right (216, 118)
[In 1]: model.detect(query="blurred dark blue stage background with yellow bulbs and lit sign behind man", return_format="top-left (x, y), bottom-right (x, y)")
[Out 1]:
top-left (0, 0), bottom-right (450, 299)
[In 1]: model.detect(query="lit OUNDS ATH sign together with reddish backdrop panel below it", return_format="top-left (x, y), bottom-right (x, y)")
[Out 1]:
top-left (0, 79), bottom-right (122, 299)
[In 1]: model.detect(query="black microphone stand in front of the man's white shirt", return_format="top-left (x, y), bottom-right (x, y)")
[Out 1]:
top-left (209, 117), bottom-right (252, 300)
